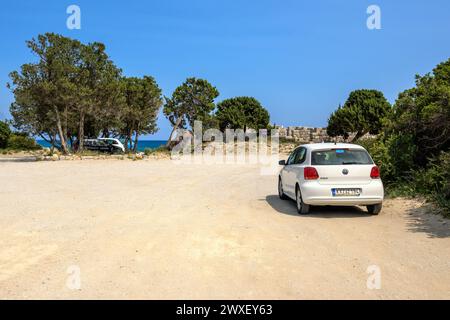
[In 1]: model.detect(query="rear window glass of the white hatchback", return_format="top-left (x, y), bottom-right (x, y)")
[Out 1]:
top-left (311, 149), bottom-right (373, 166)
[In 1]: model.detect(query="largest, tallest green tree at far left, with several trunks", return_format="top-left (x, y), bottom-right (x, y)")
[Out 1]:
top-left (8, 33), bottom-right (122, 153)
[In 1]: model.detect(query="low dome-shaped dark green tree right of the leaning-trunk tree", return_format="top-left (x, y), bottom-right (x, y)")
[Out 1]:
top-left (216, 97), bottom-right (270, 130)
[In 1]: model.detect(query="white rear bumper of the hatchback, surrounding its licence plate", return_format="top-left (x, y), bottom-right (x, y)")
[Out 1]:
top-left (300, 179), bottom-right (384, 206)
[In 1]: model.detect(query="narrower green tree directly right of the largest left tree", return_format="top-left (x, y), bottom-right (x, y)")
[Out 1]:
top-left (121, 76), bottom-right (163, 152)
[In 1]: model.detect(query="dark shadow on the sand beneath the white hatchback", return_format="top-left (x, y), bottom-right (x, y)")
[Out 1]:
top-left (265, 195), bottom-right (371, 218)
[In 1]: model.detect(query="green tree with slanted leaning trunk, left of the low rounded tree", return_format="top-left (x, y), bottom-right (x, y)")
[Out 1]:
top-left (163, 78), bottom-right (219, 146)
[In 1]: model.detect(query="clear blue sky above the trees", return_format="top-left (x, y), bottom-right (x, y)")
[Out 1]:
top-left (0, 0), bottom-right (450, 139)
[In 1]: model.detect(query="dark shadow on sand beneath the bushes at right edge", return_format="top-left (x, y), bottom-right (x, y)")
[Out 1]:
top-left (406, 203), bottom-right (450, 238)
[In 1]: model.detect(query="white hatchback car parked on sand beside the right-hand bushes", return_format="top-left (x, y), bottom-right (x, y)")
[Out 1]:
top-left (278, 143), bottom-right (384, 214)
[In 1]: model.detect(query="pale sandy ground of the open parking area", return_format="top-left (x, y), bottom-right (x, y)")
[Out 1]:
top-left (0, 160), bottom-right (450, 299)
